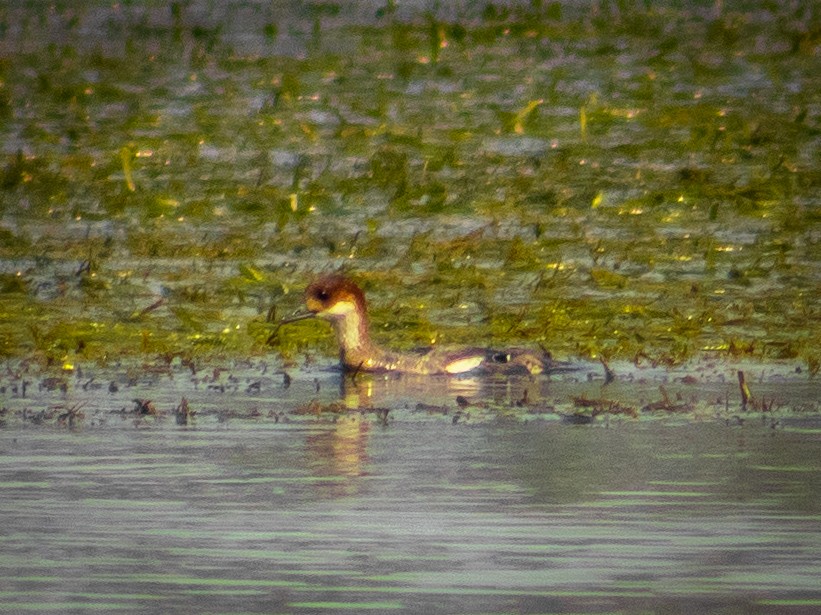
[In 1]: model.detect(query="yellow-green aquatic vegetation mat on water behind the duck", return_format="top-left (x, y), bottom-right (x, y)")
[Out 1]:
top-left (0, 0), bottom-right (821, 373)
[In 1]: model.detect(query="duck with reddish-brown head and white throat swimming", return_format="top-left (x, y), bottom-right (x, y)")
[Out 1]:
top-left (280, 273), bottom-right (575, 376)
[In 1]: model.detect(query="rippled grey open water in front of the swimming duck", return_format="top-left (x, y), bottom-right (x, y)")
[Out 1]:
top-left (0, 364), bottom-right (821, 613)
